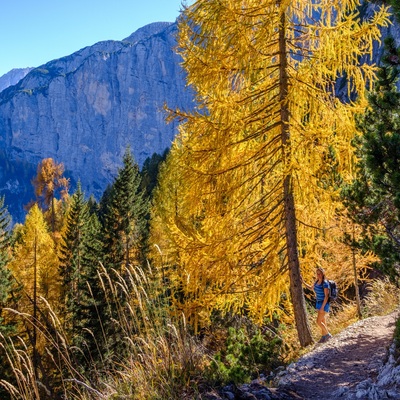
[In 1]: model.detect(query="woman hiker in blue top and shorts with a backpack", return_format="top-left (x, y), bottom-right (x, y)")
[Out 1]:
top-left (301, 267), bottom-right (332, 343)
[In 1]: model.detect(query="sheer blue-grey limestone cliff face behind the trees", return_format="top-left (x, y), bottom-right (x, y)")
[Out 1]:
top-left (0, 23), bottom-right (193, 209)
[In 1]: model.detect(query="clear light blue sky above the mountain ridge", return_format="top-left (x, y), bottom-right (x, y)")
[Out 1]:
top-left (0, 0), bottom-right (194, 76)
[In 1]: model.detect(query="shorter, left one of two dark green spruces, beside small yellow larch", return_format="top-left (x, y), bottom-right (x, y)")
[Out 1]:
top-left (60, 183), bottom-right (104, 365)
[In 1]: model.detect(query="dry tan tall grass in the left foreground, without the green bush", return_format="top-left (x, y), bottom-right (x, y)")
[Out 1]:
top-left (0, 267), bottom-right (205, 400)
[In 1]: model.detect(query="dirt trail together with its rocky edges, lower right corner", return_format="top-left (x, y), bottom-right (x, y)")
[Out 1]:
top-left (205, 311), bottom-right (400, 400)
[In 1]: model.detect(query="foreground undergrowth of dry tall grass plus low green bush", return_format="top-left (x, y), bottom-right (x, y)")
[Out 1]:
top-left (0, 267), bottom-right (285, 400)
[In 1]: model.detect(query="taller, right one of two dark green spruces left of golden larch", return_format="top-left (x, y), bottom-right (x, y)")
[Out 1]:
top-left (100, 148), bottom-right (148, 357)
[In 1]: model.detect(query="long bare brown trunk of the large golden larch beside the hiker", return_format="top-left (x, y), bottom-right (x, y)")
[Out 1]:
top-left (279, 7), bottom-right (313, 347)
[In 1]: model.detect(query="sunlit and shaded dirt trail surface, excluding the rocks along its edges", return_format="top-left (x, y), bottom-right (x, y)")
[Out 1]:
top-left (278, 311), bottom-right (400, 400)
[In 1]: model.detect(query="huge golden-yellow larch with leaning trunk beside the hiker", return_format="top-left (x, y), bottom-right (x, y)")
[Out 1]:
top-left (154, 0), bottom-right (387, 345)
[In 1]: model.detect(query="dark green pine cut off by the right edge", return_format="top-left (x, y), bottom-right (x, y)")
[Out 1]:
top-left (343, 37), bottom-right (400, 278)
